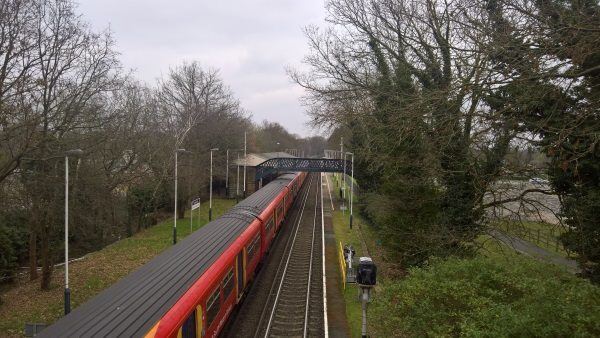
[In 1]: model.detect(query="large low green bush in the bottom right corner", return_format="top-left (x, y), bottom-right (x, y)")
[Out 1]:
top-left (371, 257), bottom-right (600, 337)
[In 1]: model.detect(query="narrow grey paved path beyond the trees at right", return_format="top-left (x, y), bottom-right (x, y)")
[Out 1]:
top-left (488, 228), bottom-right (580, 273)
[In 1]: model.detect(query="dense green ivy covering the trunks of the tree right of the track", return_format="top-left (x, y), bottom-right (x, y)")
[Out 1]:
top-left (348, 36), bottom-right (482, 266)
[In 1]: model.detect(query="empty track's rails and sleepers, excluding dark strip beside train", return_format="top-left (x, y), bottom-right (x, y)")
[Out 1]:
top-left (247, 175), bottom-right (324, 337)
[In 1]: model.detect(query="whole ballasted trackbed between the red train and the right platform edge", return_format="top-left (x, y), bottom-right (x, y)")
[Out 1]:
top-left (221, 174), bottom-right (326, 338)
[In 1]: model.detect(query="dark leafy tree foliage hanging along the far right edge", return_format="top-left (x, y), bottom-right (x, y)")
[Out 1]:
top-left (506, 0), bottom-right (600, 283)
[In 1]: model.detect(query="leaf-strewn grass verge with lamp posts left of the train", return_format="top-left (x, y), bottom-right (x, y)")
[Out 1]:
top-left (0, 199), bottom-right (235, 337)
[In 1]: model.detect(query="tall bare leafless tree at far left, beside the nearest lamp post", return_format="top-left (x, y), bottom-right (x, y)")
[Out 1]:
top-left (2, 0), bottom-right (118, 288)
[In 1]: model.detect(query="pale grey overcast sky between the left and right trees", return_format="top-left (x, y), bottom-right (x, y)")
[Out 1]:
top-left (79, 0), bottom-right (325, 136)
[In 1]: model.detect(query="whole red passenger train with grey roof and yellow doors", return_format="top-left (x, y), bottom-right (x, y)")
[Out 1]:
top-left (40, 173), bottom-right (306, 338)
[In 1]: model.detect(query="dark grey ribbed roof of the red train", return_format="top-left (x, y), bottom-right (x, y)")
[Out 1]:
top-left (39, 174), bottom-right (295, 337)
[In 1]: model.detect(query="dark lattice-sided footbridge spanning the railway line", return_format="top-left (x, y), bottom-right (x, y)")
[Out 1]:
top-left (256, 157), bottom-right (352, 181)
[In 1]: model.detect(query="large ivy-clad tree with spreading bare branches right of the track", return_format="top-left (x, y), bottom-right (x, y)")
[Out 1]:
top-left (290, 0), bottom-right (564, 261)
